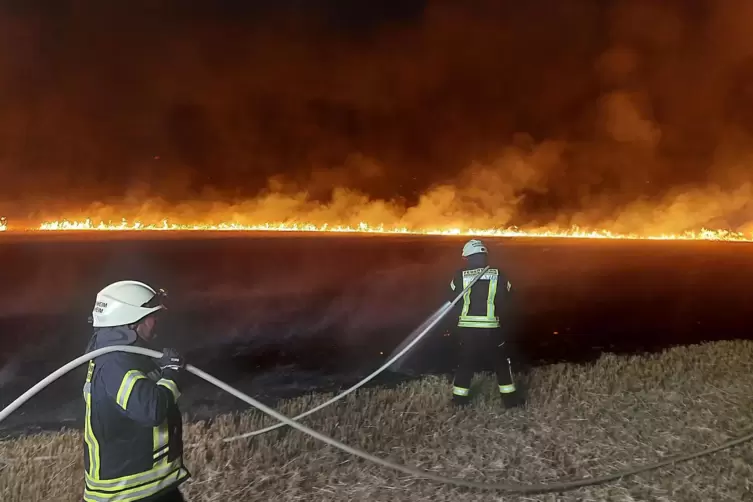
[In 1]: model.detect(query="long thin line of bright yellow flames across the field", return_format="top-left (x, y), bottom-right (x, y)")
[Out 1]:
top-left (0, 218), bottom-right (736, 242)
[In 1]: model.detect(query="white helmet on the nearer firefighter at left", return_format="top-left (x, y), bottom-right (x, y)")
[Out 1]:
top-left (92, 281), bottom-right (166, 328)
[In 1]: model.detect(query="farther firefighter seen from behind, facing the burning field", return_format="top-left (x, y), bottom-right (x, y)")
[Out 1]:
top-left (449, 239), bottom-right (520, 407)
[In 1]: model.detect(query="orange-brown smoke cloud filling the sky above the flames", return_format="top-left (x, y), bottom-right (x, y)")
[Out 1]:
top-left (0, 0), bottom-right (753, 233)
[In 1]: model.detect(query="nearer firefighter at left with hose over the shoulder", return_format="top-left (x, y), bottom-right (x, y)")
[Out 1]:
top-left (79, 281), bottom-right (191, 502)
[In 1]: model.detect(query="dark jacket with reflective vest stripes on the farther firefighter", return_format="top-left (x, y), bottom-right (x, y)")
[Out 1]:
top-left (448, 256), bottom-right (512, 329)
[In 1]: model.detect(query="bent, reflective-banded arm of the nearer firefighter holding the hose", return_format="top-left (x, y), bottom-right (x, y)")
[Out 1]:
top-left (100, 357), bottom-right (180, 427)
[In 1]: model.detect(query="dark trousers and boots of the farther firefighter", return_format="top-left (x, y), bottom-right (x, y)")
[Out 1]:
top-left (452, 327), bottom-right (519, 406)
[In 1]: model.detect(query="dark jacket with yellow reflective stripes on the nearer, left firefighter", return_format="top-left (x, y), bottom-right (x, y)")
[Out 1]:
top-left (84, 327), bottom-right (190, 502)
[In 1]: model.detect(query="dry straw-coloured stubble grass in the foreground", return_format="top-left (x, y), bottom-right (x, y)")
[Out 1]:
top-left (0, 341), bottom-right (753, 502)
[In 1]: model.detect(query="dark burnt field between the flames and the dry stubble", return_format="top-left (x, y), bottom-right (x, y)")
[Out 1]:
top-left (0, 233), bottom-right (753, 431)
